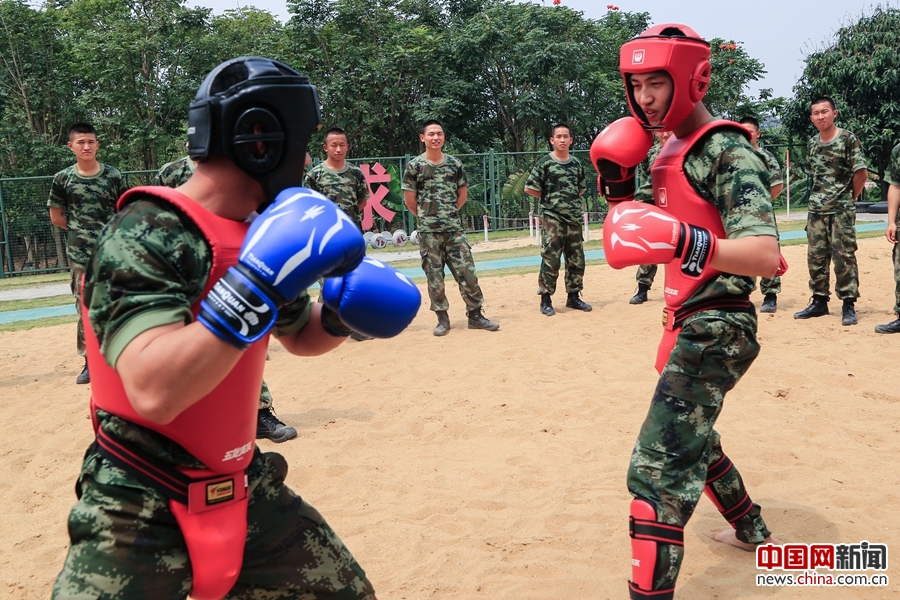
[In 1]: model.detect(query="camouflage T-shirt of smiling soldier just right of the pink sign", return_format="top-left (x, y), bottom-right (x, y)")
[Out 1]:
top-left (401, 154), bottom-right (469, 233)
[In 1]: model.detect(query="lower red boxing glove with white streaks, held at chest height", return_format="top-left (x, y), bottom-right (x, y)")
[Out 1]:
top-left (603, 202), bottom-right (718, 277)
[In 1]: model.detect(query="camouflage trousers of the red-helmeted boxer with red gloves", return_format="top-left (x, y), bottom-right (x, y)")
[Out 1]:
top-left (627, 311), bottom-right (770, 590)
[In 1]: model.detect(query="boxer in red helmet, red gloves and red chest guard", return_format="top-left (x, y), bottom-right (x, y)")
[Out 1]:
top-left (591, 24), bottom-right (786, 600)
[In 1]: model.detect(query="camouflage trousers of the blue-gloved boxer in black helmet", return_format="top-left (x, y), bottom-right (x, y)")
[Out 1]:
top-left (53, 452), bottom-right (375, 600)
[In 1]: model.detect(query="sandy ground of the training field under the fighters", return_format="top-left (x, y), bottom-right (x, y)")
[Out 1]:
top-left (0, 238), bottom-right (900, 600)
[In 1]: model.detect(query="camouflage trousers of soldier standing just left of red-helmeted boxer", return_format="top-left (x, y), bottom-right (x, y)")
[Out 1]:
top-left (538, 214), bottom-right (584, 295)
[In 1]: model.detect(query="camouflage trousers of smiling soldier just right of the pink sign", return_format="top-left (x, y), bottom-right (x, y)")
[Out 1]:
top-left (419, 231), bottom-right (484, 312)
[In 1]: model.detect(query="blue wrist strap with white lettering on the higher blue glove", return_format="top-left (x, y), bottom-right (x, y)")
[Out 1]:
top-left (198, 267), bottom-right (278, 350)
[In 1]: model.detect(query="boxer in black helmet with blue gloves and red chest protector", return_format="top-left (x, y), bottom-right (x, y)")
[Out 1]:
top-left (53, 57), bottom-right (421, 600)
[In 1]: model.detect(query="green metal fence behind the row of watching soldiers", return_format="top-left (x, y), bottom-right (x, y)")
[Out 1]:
top-left (0, 144), bottom-right (836, 277)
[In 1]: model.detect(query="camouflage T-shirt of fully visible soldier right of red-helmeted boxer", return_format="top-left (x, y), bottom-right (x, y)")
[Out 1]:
top-left (806, 129), bottom-right (866, 214)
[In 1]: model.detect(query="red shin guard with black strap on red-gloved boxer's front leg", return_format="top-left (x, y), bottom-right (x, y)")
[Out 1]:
top-left (628, 498), bottom-right (684, 600)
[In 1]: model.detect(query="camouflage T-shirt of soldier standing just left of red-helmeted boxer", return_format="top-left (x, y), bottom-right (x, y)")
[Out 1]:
top-left (525, 154), bottom-right (586, 225)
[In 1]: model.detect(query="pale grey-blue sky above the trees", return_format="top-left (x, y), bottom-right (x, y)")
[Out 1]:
top-left (197, 0), bottom-right (900, 97)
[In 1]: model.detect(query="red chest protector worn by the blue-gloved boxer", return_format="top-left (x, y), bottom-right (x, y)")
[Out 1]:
top-left (82, 187), bottom-right (268, 474)
